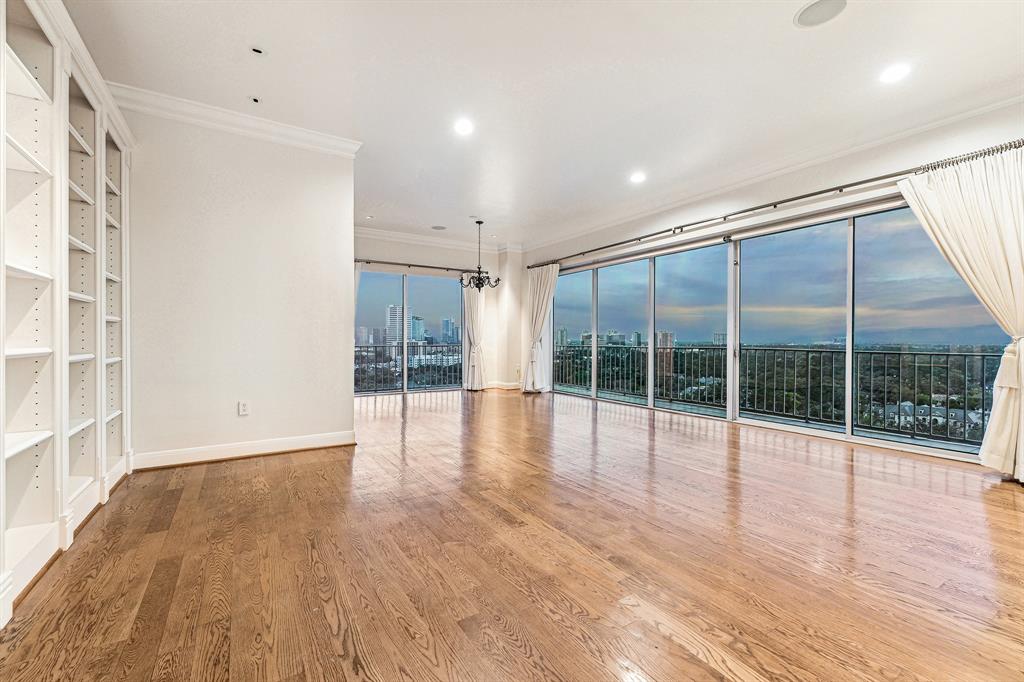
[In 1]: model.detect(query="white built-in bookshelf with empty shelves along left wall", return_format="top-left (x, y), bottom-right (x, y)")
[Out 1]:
top-left (0, 0), bottom-right (131, 626)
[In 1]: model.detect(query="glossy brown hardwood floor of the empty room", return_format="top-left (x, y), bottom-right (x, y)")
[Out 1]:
top-left (0, 392), bottom-right (1024, 682)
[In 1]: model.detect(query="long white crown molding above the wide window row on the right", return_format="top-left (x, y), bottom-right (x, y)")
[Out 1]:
top-left (525, 94), bottom-right (1024, 253)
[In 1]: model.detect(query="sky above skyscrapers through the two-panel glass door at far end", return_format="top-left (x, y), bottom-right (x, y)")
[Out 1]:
top-left (355, 271), bottom-right (462, 337)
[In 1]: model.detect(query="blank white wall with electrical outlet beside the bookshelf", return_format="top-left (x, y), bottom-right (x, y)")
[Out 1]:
top-left (127, 113), bottom-right (354, 467)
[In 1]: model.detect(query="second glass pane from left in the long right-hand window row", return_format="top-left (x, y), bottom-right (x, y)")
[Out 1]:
top-left (597, 260), bottom-right (650, 404)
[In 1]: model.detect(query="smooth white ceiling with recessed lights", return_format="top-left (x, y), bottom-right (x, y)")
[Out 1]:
top-left (66, 0), bottom-right (1024, 247)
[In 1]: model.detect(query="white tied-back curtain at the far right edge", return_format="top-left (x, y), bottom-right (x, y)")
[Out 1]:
top-left (899, 144), bottom-right (1024, 480)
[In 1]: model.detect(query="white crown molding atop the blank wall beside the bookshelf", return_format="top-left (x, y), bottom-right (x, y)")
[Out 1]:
top-left (106, 81), bottom-right (362, 159)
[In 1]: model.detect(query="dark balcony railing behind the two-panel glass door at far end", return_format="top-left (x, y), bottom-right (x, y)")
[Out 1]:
top-left (354, 343), bottom-right (462, 393)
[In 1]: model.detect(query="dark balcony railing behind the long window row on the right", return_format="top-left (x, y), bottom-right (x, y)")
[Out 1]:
top-left (554, 345), bottom-right (999, 446)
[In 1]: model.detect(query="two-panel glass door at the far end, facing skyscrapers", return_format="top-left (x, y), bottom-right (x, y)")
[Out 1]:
top-left (354, 272), bottom-right (463, 393)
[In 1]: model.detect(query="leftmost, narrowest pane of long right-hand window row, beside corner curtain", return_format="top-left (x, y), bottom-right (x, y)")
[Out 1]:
top-left (552, 270), bottom-right (594, 395)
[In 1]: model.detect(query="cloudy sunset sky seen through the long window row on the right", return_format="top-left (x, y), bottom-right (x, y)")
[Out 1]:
top-left (555, 209), bottom-right (1008, 346)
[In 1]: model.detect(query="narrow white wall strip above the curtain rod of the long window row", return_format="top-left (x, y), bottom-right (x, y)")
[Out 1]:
top-left (525, 102), bottom-right (1024, 264)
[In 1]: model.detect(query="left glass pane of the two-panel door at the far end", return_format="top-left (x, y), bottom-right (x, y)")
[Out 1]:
top-left (354, 272), bottom-right (401, 393)
